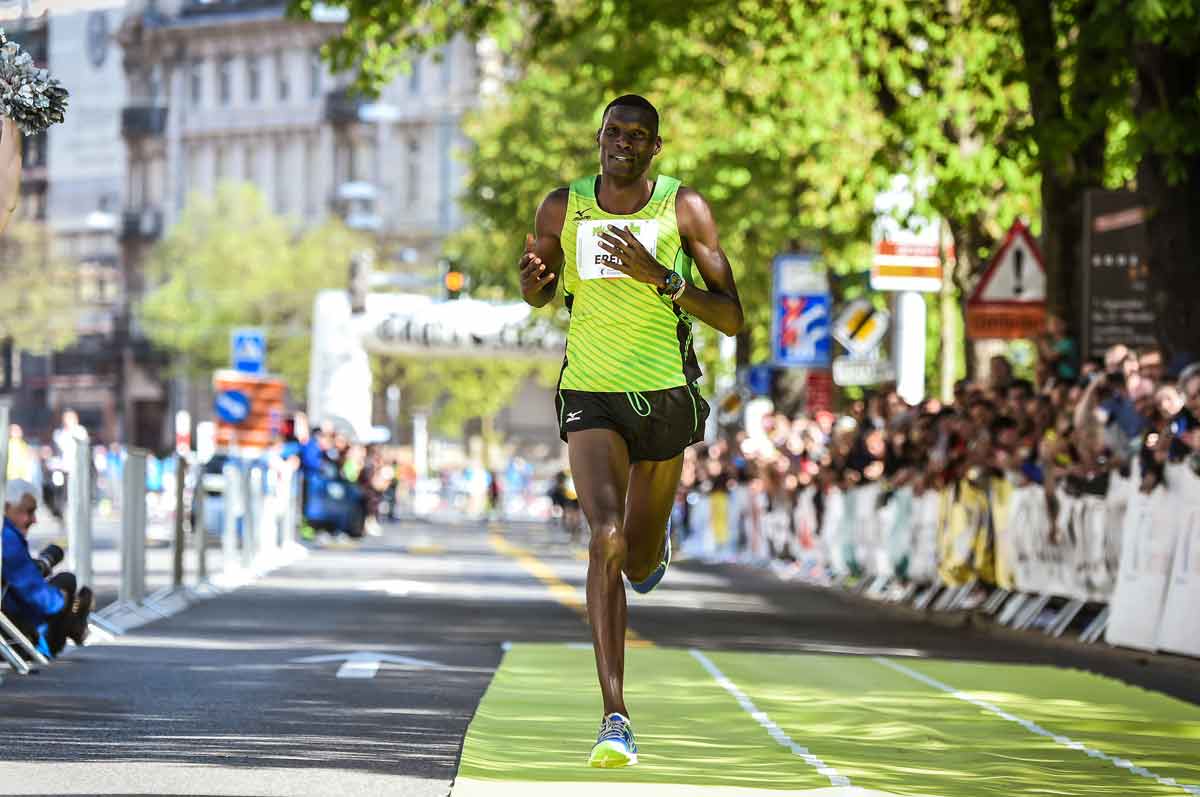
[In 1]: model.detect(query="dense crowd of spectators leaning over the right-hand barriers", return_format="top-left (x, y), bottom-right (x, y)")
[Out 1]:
top-left (680, 334), bottom-right (1200, 556)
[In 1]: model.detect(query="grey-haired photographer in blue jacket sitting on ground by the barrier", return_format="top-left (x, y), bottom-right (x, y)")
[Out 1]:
top-left (2, 479), bottom-right (91, 655)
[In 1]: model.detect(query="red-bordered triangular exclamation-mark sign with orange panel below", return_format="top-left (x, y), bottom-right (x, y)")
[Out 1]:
top-left (967, 221), bottom-right (1046, 340)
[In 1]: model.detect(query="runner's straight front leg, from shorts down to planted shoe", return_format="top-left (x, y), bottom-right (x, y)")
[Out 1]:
top-left (566, 429), bottom-right (630, 717)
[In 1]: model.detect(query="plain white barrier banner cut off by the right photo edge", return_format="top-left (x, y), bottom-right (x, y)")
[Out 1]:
top-left (1158, 465), bottom-right (1200, 655)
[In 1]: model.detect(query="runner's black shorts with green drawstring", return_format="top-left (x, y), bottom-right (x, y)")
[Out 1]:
top-left (554, 384), bottom-right (708, 462)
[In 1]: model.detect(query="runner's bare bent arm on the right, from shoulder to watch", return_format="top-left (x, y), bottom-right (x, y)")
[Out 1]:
top-left (676, 187), bottom-right (744, 335)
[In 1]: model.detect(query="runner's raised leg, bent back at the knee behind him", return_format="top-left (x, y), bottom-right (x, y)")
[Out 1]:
top-left (625, 454), bottom-right (683, 581)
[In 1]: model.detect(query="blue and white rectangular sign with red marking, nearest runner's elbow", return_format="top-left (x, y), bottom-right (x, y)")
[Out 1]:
top-left (770, 253), bottom-right (832, 368)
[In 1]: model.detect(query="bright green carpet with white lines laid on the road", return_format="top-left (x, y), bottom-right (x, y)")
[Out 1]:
top-left (458, 645), bottom-right (1200, 797)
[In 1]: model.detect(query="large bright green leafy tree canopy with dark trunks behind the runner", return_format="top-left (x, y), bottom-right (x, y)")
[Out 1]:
top-left (293, 0), bottom-right (1200, 360)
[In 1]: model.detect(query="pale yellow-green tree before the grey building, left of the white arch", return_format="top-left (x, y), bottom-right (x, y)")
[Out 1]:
top-left (140, 182), bottom-right (367, 396)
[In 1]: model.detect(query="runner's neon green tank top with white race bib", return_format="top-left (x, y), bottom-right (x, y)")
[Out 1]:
top-left (559, 175), bottom-right (701, 392)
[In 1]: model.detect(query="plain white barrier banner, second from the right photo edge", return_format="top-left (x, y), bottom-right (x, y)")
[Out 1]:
top-left (1104, 487), bottom-right (1176, 651)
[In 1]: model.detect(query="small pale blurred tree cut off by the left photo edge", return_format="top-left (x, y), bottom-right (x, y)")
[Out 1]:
top-left (0, 221), bottom-right (82, 353)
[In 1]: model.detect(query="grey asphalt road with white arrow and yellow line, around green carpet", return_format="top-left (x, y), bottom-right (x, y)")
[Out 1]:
top-left (0, 523), bottom-right (1200, 797)
